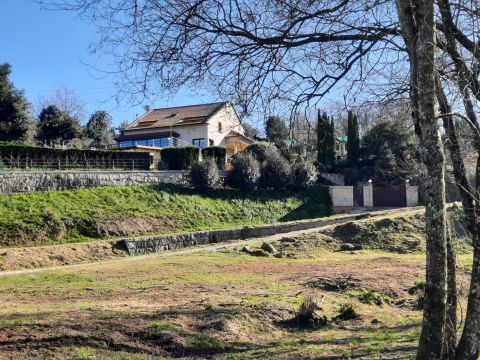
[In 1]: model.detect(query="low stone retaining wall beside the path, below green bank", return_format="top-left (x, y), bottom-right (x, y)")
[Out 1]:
top-left (122, 214), bottom-right (368, 255)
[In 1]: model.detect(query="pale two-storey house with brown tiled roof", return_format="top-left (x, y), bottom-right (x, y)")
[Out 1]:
top-left (117, 102), bottom-right (253, 157)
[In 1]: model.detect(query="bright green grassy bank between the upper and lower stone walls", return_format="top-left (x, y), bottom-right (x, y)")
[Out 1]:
top-left (0, 185), bottom-right (331, 246)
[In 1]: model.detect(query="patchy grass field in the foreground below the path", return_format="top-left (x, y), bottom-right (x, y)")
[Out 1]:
top-left (0, 212), bottom-right (471, 360)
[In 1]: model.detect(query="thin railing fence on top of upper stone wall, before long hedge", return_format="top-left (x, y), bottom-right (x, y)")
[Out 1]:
top-left (0, 159), bottom-right (150, 172)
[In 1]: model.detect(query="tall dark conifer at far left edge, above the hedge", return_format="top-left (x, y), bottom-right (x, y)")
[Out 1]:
top-left (0, 64), bottom-right (32, 141)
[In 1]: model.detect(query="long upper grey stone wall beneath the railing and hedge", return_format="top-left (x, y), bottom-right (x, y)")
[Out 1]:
top-left (0, 171), bottom-right (189, 194)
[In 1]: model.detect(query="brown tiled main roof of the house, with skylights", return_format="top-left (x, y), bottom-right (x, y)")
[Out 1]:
top-left (124, 102), bottom-right (227, 131)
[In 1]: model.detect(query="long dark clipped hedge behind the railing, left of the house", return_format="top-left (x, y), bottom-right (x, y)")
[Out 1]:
top-left (0, 142), bottom-right (150, 170)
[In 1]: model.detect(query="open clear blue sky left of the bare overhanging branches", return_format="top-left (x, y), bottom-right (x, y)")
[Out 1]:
top-left (0, 0), bottom-right (215, 125)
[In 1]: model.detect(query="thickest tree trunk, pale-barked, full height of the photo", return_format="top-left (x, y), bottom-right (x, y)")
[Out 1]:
top-left (397, 0), bottom-right (447, 359)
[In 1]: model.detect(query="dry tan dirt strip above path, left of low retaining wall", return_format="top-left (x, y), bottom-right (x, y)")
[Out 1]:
top-left (0, 240), bottom-right (128, 271)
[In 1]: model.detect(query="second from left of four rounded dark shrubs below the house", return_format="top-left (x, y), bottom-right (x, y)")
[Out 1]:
top-left (227, 152), bottom-right (260, 190)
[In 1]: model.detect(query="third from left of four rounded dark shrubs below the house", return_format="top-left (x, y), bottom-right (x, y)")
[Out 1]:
top-left (260, 154), bottom-right (292, 189)
